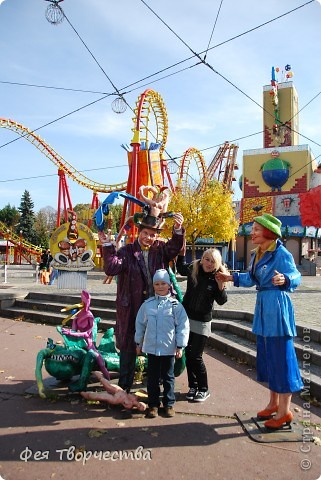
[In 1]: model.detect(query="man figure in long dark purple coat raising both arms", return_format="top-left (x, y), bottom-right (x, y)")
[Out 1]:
top-left (98, 213), bottom-right (185, 392)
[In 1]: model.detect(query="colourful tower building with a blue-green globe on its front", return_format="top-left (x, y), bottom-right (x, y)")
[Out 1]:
top-left (237, 66), bottom-right (321, 265)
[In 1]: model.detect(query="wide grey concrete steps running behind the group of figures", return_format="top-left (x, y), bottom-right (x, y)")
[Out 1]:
top-left (0, 292), bottom-right (321, 398)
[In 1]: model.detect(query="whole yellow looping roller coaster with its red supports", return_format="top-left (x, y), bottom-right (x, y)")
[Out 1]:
top-left (0, 89), bottom-right (238, 256)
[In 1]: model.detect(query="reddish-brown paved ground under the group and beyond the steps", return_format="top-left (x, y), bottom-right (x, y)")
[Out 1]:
top-left (0, 277), bottom-right (321, 480)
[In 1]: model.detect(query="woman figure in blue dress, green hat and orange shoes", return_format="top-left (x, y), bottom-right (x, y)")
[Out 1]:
top-left (216, 213), bottom-right (303, 429)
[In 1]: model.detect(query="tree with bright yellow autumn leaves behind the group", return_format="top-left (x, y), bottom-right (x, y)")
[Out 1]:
top-left (163, 180), bottom-right (238, 259)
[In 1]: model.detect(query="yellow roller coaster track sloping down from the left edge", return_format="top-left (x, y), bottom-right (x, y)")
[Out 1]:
top-left (0, 118), bottom-right (127, 193)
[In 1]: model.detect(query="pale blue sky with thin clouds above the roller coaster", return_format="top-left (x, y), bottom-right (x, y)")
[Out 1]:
top-left (0, 0), bottom-right (321, 211)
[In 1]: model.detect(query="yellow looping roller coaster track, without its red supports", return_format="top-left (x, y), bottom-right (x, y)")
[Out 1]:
top-left (0, 118), bottom-right (238, 221)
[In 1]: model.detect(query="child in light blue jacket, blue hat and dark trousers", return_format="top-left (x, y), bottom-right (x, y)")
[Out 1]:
top-left (135, 269), bottom-right (189, 418)
